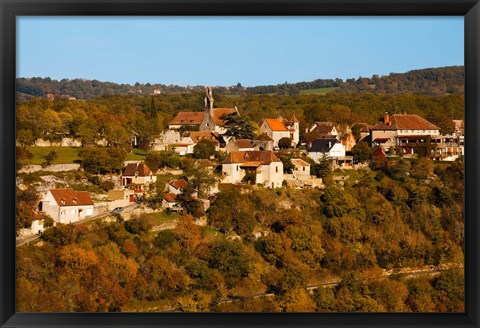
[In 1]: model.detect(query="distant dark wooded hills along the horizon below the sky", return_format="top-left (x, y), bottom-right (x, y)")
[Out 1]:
top-left (16, 66), bottom-right (465, 101)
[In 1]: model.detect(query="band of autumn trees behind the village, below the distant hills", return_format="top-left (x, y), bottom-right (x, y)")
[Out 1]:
top-left (16, 92), bottom-right (464, 149)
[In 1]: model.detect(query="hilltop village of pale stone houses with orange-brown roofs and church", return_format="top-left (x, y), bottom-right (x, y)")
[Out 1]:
top-left (19, 87), bottom-right (464, 238)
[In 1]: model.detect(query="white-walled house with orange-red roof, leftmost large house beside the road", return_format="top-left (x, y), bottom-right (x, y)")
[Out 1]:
top-left (39, 189), bottom-right (94, 223)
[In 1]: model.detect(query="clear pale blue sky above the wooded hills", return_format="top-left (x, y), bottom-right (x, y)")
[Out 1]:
top-left (17, 16), bottom-right (464, 86)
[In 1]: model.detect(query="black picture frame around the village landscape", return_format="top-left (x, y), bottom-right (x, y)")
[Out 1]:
top-left (0, 0), bottom-right (480, 327)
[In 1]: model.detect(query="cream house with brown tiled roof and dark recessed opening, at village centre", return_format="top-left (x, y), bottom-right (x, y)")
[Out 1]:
top-left (222, 150), bottom-right (284, 188)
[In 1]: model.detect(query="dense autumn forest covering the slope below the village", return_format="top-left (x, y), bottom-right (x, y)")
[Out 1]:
top-left (17, 159), bottom-right (464, 312)
